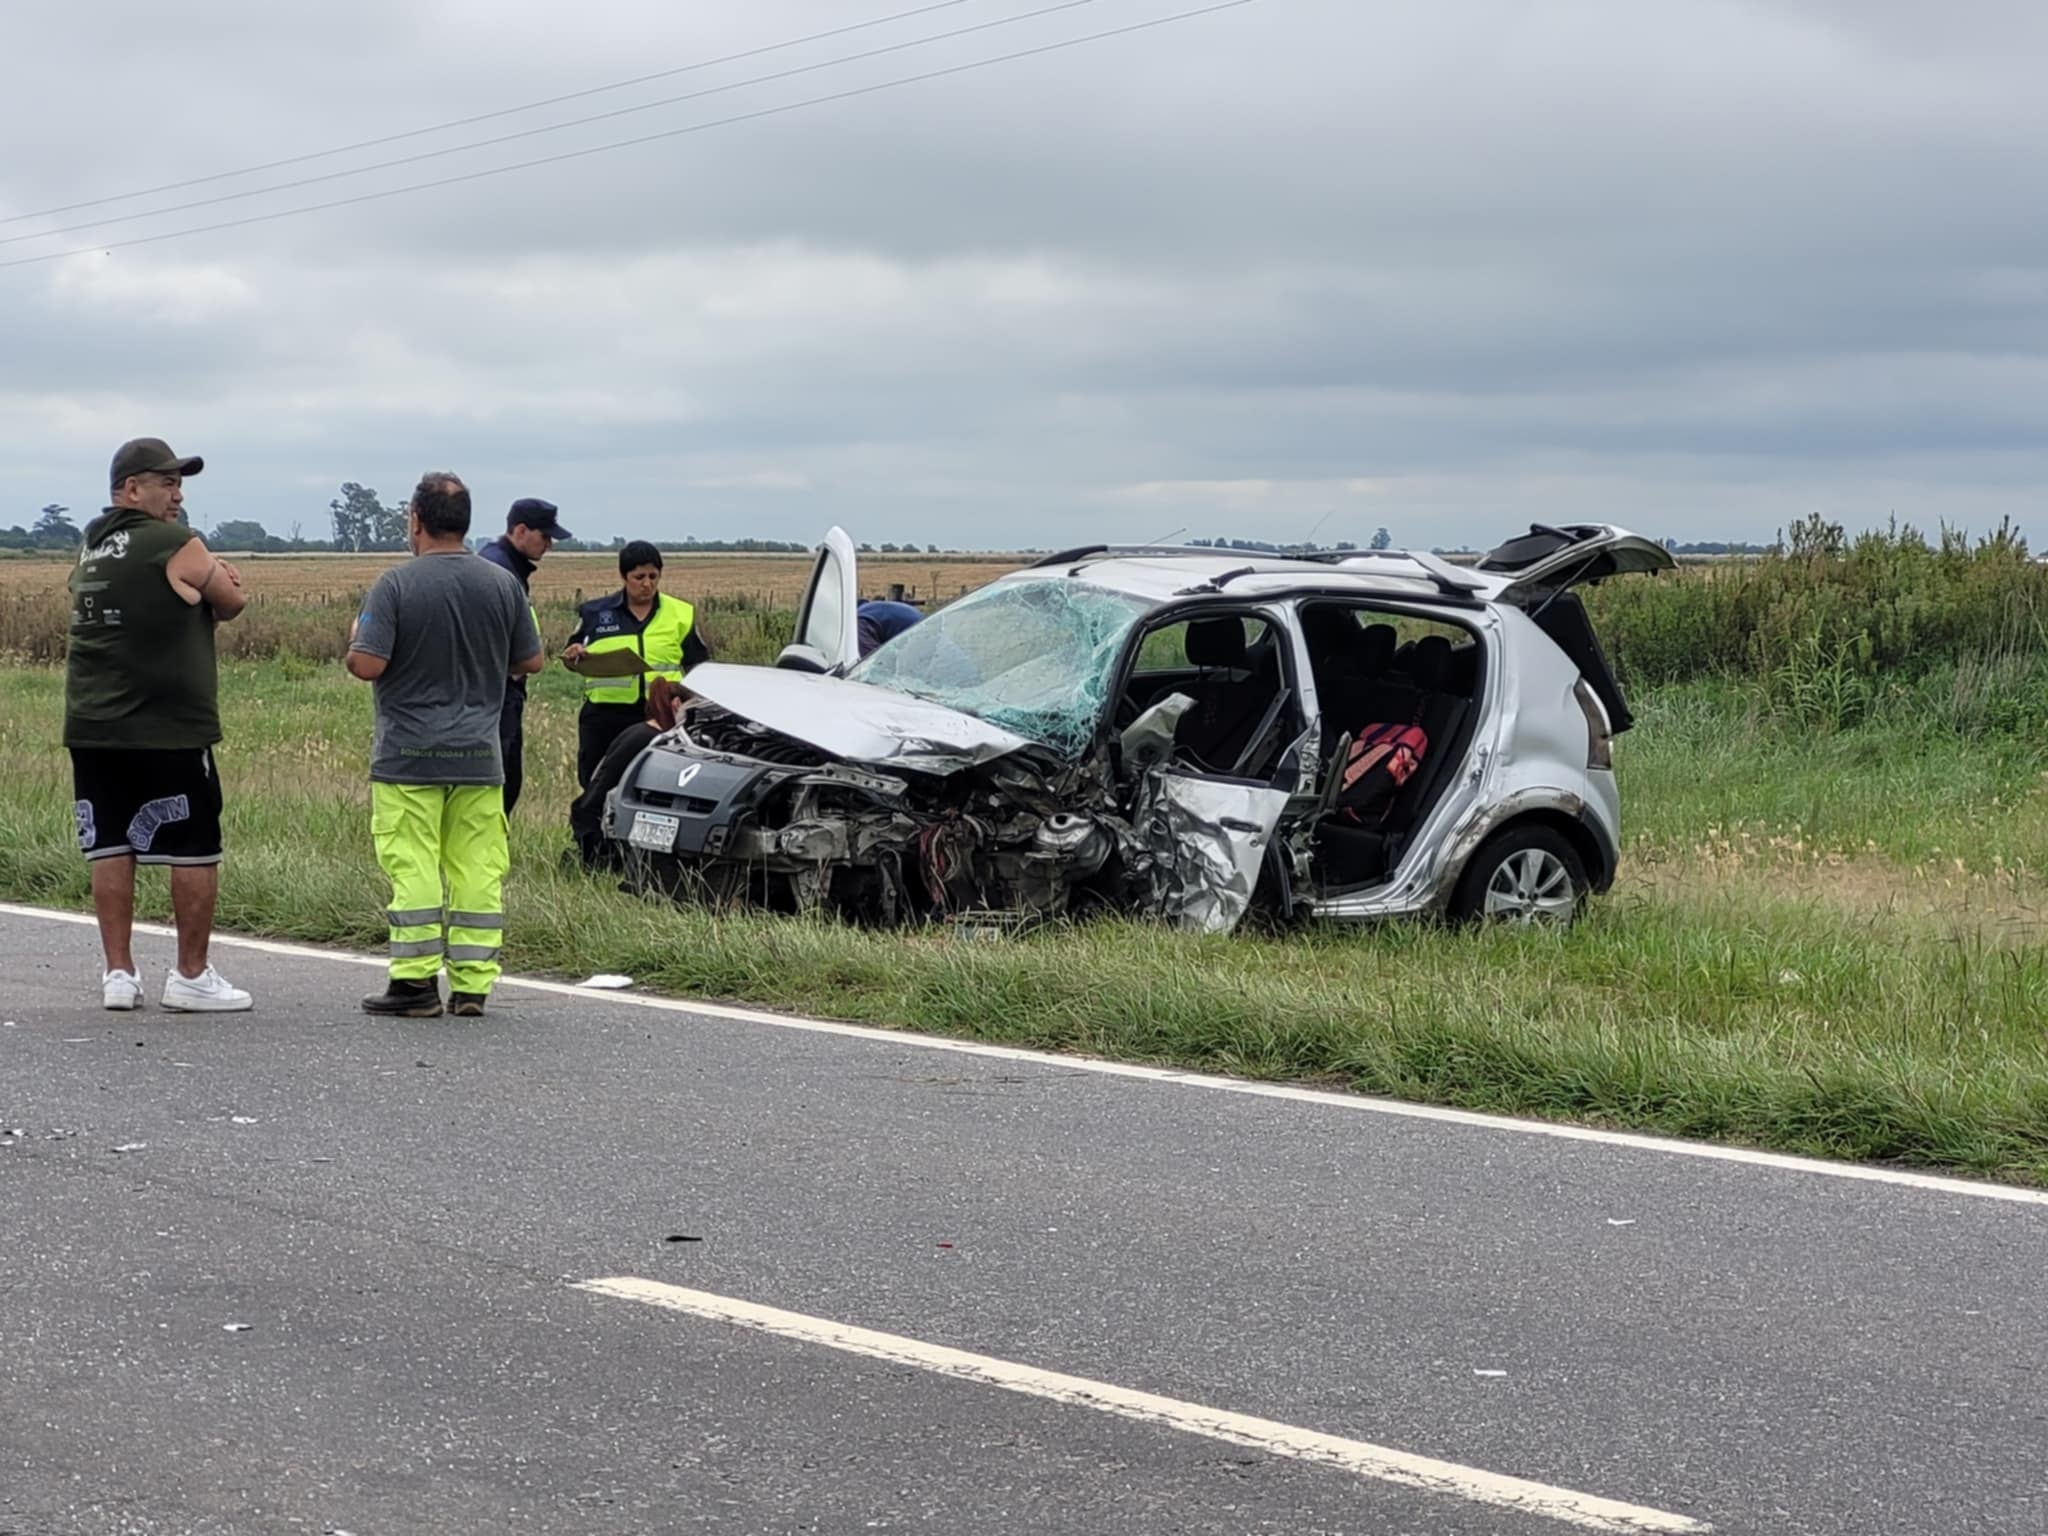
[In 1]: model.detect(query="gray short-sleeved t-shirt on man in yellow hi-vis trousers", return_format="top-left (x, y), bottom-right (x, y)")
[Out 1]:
top-left (352, 551), bottom-right (541, 784)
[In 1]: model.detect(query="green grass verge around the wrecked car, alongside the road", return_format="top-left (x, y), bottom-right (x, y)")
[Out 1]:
top-left (0, 655), bottom-right (2048, 1184)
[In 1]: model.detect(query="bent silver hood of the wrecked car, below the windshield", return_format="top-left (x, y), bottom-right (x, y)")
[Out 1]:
top-left (684, 662), bottom-right (1032, 774)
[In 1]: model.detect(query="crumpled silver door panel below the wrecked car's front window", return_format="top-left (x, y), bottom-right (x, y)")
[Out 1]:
top-left (1139, 774), bottom-right (1288, 934)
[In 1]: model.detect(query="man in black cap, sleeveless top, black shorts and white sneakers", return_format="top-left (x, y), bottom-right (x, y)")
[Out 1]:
top-left (63, 438), bottom-right (250, 1014)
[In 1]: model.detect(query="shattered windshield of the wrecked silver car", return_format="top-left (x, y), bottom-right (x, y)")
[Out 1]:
top-left (850, 580), bottom-right (1151, 758)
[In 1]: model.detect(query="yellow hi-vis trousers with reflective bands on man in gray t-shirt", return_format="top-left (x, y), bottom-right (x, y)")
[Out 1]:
top-left (371, 782), bottom-right (512, 993)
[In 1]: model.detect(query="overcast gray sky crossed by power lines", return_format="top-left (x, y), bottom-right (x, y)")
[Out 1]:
top-left (0, 0), bottom-right (2048, 549)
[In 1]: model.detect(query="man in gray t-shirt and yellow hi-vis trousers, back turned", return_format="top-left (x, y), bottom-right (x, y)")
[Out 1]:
top-left (348, 473), bottom-right (541, 1018)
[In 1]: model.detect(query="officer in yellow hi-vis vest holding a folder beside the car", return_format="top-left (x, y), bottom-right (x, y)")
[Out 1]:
top-left (561, 539), bottom-right (711, 788)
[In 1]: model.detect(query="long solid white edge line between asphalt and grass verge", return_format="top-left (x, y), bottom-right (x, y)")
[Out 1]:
top-left (0, 901), bottom-right (2048, 1206)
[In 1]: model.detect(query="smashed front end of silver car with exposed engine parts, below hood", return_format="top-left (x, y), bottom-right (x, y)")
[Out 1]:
top-left (614, 705), bottom-right (1286, 928)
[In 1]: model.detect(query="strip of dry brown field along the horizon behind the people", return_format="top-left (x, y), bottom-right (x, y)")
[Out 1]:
top-left (0, 553), bottom-right (1024, 608)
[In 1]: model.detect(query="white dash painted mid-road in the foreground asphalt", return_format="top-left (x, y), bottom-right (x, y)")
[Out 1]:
top-left (575, 1276), bottom-right (1712, 1532)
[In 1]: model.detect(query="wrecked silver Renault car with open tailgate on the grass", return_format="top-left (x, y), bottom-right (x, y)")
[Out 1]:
top-left (606, 526), bottom-right (1671, 932)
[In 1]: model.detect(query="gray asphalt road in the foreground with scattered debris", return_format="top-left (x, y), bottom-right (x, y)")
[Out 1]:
top-left (0, 901), bottom-right (2048, 1536)
